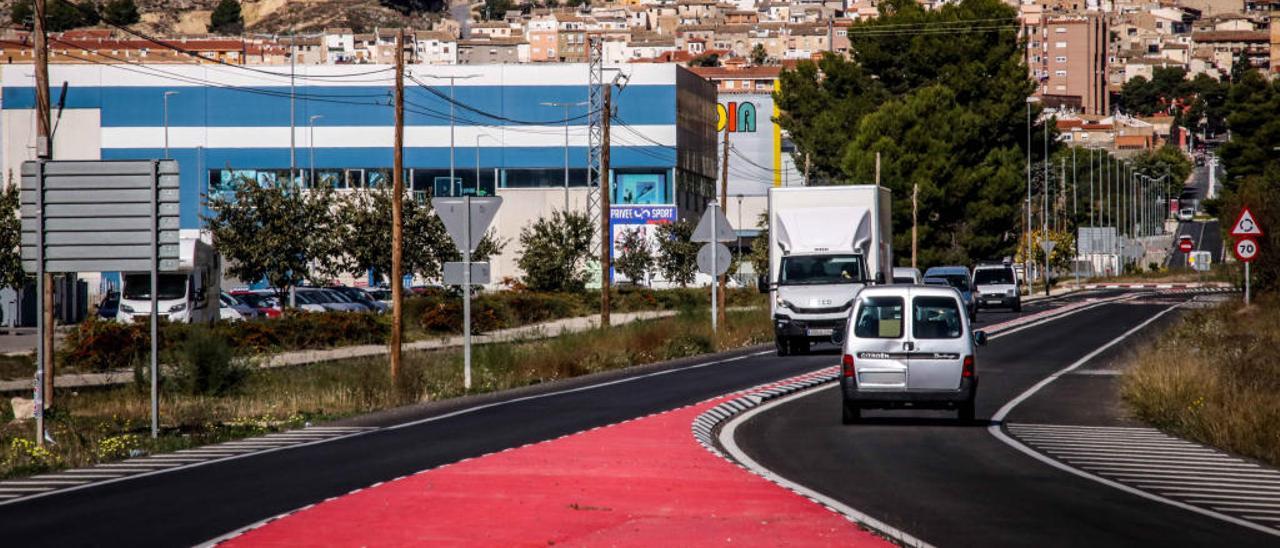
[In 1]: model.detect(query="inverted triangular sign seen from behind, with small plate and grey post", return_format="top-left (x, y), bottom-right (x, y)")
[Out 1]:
top-left (431, 195), bottom-right (502, 391)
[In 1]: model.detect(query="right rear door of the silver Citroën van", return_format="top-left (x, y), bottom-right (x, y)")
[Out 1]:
top-left (908, 294), bottom-right (969, 391)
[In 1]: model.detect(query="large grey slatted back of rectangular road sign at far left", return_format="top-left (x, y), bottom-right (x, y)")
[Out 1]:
top-left (22, 160), bottom-right (180, 273)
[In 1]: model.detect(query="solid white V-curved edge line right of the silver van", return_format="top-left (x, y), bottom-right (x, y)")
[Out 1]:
top-left (987, 305), bottom-right (1280, 536)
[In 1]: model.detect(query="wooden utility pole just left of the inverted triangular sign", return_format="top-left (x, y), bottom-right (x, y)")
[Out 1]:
top-left (390, 28), bottom-right (404, 382)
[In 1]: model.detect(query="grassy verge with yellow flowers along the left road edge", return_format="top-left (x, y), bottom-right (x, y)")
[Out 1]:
top-left (0, 309), bottom-right (773, 478)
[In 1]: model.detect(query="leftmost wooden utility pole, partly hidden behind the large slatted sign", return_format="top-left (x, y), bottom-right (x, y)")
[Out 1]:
top-left (35, 0), bottom-right (54, 446)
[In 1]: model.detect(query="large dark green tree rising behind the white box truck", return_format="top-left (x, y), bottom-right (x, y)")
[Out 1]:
top-left (774, 0), bottom-right (1034, 264)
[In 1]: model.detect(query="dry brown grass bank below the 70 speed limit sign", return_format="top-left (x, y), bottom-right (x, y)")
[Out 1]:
top-left (1121, 294), bottom-right (1280, 466)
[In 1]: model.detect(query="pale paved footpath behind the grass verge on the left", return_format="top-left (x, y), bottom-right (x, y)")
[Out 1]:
top-left (0, 310), bottom-right (676, 392)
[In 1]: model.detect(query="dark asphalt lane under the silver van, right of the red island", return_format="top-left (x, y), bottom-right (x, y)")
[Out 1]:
top-left (735, 293), bottom-right (1276, 548)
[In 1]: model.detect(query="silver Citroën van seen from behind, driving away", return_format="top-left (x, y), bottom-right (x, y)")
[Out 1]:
top-left (840, 286), bottom-right (987, 424)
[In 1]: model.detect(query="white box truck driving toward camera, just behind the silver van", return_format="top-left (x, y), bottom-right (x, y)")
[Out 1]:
top-left (760, 184), bottom-right (893, 356)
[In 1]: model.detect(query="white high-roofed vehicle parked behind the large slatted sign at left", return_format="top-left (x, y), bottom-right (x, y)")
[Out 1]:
top-left (116, 230), bottom-right (223, 324)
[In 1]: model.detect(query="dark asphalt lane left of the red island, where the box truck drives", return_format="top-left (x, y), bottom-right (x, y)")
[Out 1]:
top-left (0, 290), bottom-right (1079, 547)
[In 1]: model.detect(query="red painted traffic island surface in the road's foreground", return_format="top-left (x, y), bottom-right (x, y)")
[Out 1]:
top-left (227, 384), bottom-right (890, 547)
